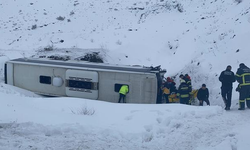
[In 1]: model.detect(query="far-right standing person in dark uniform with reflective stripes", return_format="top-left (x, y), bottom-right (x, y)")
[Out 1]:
top-left (236, 63), bottom-right (250, 110)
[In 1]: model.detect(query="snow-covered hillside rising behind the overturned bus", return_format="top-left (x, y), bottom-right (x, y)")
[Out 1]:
top-left (0, 0), bottom-right (250, 105)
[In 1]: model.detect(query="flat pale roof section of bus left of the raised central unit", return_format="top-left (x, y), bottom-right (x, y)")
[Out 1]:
top-left (14, 64), bottom-right (66, 96)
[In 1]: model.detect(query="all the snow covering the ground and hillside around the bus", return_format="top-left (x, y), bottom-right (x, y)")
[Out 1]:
top-left (0, 0), bottom-right (250, 150)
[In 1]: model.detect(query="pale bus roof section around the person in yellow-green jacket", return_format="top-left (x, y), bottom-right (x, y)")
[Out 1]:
top-left (98, 72), bottom-right (157, 104)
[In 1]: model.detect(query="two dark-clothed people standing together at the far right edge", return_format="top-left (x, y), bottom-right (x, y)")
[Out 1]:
top-left (219, 63), bottom-right (250, 110)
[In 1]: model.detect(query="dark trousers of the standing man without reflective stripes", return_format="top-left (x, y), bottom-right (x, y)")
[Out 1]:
top-left (221, 87), bottom-right (233, 108)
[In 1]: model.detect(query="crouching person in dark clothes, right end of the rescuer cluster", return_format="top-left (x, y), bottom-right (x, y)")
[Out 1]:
top-left (197, 84), bottom-right (210, 106)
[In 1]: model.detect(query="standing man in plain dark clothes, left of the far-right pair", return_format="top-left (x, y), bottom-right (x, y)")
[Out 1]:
top-left (219, 65), bottom-right (235, 110)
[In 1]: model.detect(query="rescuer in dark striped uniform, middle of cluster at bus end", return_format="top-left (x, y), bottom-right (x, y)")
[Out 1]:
top-left (177, 79), bottom-right (191, 105)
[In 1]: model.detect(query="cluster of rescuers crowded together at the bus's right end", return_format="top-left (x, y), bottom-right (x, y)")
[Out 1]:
top-left (162, 74), bottom-right (210, 106)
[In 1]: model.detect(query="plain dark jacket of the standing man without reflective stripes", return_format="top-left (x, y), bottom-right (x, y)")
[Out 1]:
top-left (219, 70), bottom-right (235, 87)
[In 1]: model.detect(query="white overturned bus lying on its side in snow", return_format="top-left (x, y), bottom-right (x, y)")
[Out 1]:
top-left (5, 58), bottom-right (166, 104)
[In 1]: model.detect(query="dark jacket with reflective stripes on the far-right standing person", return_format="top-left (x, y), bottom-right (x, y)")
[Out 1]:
top-left (236, 66), bottom-right (250, 86)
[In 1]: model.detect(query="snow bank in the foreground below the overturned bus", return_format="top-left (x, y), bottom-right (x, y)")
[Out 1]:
top-left (0, 94), bottom-right (250, 150)
